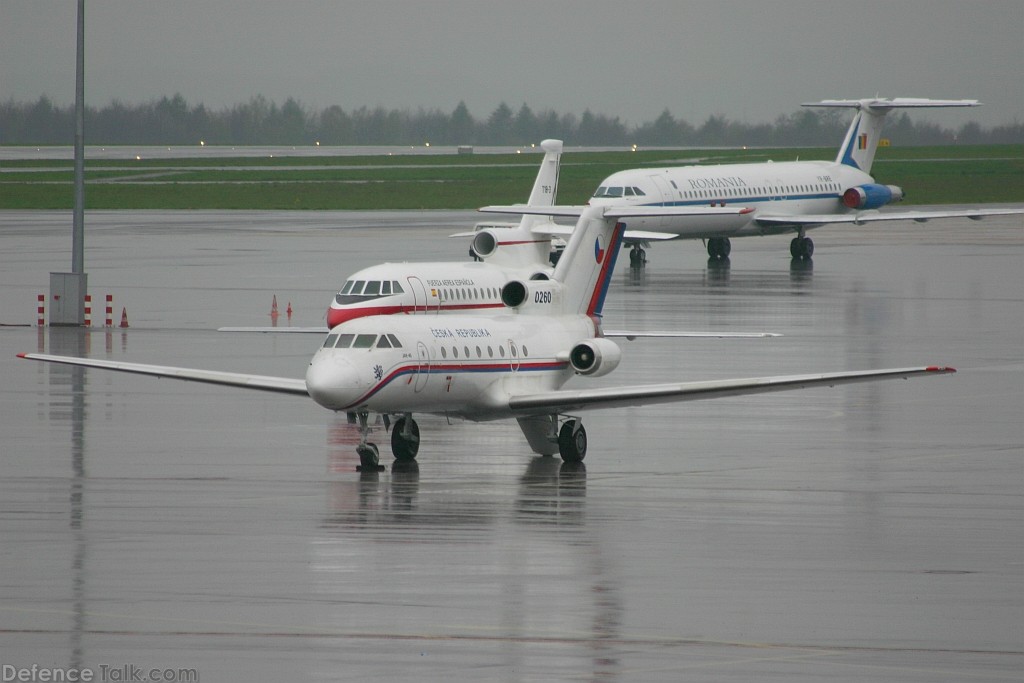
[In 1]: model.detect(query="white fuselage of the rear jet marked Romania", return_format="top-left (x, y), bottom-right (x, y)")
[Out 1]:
top-left (590, 161), bottom-right (872, 238)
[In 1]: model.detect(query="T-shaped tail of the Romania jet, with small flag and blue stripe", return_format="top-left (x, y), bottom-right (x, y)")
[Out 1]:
top-left (802, 97), bottom-right (980, 173)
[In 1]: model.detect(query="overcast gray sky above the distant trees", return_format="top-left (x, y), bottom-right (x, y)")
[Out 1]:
top-left (0, 0), bottom-right (1024, 127)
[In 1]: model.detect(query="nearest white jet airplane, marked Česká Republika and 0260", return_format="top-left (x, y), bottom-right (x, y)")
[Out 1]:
top-left (18, 207), bottom-right (955, 469)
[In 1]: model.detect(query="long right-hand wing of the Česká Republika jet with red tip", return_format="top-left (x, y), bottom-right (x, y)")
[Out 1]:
top-left (509, 366), bottom-right (956, 417)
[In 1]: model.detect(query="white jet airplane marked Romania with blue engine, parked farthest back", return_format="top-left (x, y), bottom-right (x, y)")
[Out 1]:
top-left (507, 98), bottom-right (1024, 266)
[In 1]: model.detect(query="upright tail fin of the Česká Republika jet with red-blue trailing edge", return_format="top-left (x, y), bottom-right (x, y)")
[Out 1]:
top-left (553, 206), bottom-right (626, 316)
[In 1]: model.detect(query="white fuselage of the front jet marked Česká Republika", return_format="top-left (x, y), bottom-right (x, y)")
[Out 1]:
top-left (306, 313), bottom-right (597, 420)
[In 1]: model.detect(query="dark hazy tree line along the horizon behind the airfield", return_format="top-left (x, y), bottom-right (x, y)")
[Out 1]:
top-left (0, 94), bottom-right (1024, 146)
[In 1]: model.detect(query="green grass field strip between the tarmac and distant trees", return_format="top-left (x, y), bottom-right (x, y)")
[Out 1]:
top-left (0, 145), bottom-right (1024, 210)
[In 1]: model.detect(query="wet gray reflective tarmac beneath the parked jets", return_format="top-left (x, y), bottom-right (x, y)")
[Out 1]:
top-left (0, 212), bottom-right (1024, 682)
